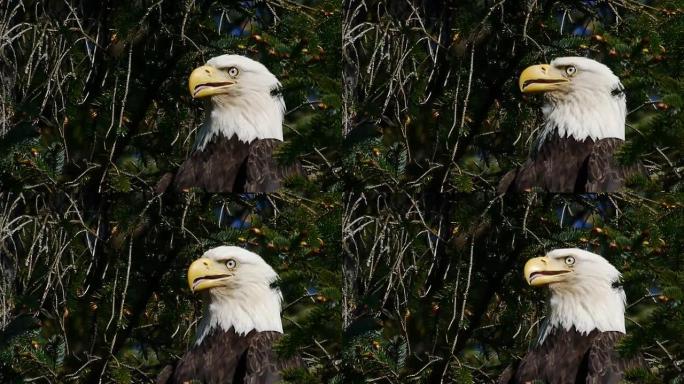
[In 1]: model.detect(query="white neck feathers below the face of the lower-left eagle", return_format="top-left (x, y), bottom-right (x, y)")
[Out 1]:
top-left (195, 283), bottom-right (283, 345)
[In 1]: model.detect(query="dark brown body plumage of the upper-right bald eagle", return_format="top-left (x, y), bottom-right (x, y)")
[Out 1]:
top-left (497, 134), bottom-right (644, 193)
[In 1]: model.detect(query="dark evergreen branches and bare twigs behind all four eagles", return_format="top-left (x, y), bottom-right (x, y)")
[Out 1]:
top-left (0, 0), bottom-right (684, 383)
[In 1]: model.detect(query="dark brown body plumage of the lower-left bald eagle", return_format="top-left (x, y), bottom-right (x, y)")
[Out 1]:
top-left (157, 328), bottom-right (304, 384)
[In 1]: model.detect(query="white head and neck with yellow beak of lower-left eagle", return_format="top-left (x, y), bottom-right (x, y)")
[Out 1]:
top-left (188, 246), bottom-right (283, 344)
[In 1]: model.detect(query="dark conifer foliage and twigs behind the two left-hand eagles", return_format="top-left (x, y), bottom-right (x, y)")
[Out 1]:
top-left (0, 0), bottom-right (342, 383)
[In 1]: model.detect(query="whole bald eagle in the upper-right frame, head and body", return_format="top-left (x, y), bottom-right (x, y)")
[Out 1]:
top-left (498, 57), bottom-right (644, 193)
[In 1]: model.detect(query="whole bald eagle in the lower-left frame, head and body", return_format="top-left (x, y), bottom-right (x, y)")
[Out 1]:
top-left (157, 246), bottom-right (303, 384)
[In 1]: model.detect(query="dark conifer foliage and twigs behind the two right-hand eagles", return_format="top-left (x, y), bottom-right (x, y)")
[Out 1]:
top-left (342, 0), bottom-right (684, 383)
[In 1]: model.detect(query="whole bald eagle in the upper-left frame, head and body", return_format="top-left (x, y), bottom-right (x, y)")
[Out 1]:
top-left (162, 55), bottom-right (301, 193)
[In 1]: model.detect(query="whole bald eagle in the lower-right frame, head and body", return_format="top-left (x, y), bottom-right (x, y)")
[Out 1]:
top-left (499, 248), bottom-right (644, 384)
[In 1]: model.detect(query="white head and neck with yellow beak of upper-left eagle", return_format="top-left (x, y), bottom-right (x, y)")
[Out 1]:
top-left (188, 55), bottom-right (285, 150)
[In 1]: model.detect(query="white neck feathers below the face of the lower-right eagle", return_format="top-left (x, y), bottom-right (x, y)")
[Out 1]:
top-left (538, 281), bottom-right (626, 345)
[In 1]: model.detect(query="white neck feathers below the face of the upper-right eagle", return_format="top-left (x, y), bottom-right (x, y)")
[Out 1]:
top-left (540, 85), bottom-right (627, 143)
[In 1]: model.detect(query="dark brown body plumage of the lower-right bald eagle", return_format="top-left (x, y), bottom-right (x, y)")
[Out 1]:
top-left (498, 328), bottom-right (645, 384)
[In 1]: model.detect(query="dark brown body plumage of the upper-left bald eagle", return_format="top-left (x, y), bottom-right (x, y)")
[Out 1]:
top-left (173, 135), bottom-right (303, 193)
